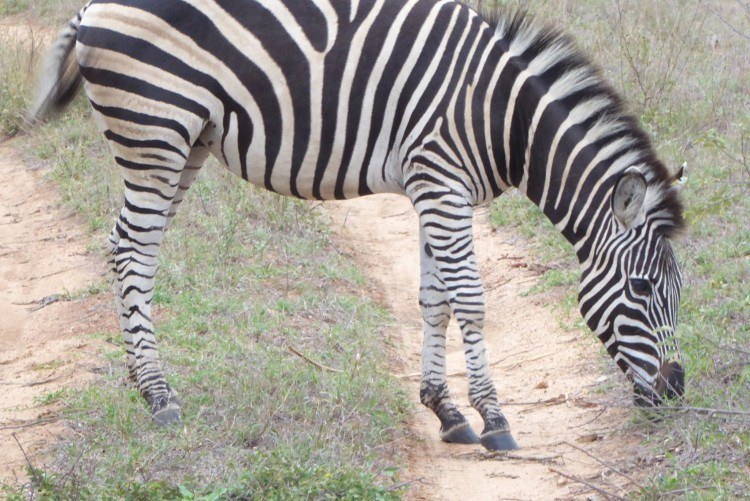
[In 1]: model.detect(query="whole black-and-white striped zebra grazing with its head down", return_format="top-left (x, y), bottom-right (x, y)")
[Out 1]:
top-left (31, 0), bottom-right (684, 449)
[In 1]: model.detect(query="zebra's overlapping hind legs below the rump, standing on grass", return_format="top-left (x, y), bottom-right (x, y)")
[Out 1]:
top-left (109, 145), bottom-right (207, 424)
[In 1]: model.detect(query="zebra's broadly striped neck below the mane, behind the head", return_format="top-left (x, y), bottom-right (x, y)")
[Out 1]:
top-left (493, 84), bottom-right (641, 263)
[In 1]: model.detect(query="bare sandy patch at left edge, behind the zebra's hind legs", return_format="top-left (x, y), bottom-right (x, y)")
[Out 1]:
top-left (0, 143), bottom-right (110, 485)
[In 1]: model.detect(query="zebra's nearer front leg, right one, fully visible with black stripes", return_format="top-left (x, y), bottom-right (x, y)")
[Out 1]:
top-left (411, 185), bottom-right (518, 450)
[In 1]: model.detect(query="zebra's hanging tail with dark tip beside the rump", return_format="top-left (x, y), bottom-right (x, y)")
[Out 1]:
top-left (25, 2), bottom-right (91, 128)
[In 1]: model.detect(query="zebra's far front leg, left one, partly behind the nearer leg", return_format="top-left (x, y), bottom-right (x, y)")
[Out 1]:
top-left (419, 228), bottom-right (479, 444)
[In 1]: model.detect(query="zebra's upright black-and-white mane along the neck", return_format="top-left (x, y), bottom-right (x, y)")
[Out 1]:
top-left (480, 9), bottom-right (685, 238)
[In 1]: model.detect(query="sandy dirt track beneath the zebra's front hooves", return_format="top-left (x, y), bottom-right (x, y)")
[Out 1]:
top-left (326, 196), bottom-right (637, 501)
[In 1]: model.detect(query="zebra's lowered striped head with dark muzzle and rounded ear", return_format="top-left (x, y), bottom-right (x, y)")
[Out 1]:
top-left (579, 167), bottom-right (685, 406)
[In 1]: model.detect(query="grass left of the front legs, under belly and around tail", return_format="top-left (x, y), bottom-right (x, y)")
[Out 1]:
top-left (0, 3), bottom-right (408, 499)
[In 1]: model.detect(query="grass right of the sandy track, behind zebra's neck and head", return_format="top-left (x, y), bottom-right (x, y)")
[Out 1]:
top-left (491, 0), bottom-right (750, 499)
